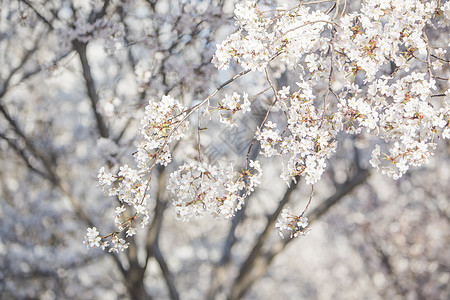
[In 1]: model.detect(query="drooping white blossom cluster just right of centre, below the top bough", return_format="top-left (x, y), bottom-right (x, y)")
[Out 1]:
top-left (256, 82), bottom-right (337, 184)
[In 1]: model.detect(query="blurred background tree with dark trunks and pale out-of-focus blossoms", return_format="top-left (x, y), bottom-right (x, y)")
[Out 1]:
top-left (0, 0), bottom-right (450, 299)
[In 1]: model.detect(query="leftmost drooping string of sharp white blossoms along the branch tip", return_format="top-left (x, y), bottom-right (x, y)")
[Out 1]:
top-left (85, 96), bottom-right (189, 251)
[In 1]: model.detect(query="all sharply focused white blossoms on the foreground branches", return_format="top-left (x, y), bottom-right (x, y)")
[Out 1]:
top-left (88, 0), bottom-right (450, 247)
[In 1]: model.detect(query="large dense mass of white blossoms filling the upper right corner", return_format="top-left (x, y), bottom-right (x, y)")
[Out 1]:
top-left (213, 0), bottom-right (450, 239)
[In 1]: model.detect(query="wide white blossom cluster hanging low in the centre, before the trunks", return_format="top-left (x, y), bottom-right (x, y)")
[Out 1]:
top-left (168, 161), bottom-right (262, 221)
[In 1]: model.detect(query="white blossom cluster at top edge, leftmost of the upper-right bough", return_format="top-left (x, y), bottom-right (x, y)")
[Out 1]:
top-left (213, 0), bottom-right (331, 71)
